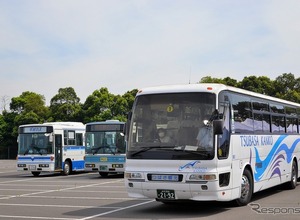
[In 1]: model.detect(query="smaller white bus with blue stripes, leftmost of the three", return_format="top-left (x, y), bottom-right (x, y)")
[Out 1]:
top-left (17, 122), bottom-right (85, 176)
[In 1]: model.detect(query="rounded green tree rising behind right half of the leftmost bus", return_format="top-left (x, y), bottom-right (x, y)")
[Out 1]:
top-left (49, 87), bottom-right (81, 121)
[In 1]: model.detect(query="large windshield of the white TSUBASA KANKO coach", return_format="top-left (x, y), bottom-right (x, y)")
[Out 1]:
top-left (127, 92), bottom-right (216, 160)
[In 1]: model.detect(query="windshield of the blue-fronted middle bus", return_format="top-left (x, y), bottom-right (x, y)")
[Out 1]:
top-left (86, 131), bottom-right (126, 154)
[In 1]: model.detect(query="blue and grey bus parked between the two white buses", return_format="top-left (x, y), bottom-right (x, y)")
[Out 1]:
top-left (85, 120), bottom-right (126, 177)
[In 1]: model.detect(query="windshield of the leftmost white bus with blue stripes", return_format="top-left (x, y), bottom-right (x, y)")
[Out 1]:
top-left (18, 133), bottom-right (53, 155)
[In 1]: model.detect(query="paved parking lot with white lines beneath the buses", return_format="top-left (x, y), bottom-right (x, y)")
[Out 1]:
top-left (0, 160), bottom-right (300, 220)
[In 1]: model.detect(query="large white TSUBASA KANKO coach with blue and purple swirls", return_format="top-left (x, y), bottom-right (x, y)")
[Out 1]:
top-left (125, 83), bottom-right (300, 205)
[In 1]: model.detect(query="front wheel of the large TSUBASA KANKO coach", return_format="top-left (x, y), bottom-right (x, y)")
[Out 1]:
top-left (236, 169), bottom-right (253, 206)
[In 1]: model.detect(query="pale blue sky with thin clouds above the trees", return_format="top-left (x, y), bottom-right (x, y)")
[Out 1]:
top-left (0, 0), bottom-right (300, 105)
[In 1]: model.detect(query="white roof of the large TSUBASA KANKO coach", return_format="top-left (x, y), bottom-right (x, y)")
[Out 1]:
top-left (136, 83), bottom-right (300, 107)
